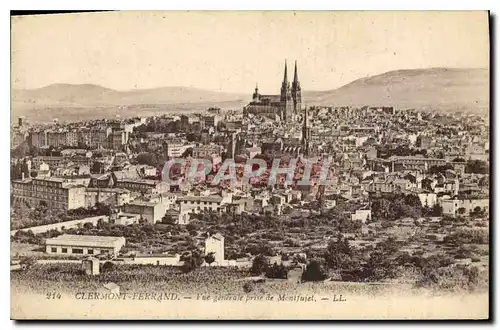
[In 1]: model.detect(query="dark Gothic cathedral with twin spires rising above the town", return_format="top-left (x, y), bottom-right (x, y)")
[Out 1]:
top-left (244, 61), bottom-right (302, 122)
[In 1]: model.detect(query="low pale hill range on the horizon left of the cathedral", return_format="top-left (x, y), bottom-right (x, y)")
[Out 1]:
top-left (11, 84), bottom-right (249, 123)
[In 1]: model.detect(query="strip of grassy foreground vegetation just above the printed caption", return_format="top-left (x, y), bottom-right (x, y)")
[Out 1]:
top-left (11, 262), bottom-right (488, 295)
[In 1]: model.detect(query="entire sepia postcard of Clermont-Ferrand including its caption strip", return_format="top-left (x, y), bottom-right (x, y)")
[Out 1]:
top-left (10, 10), bottom-right (491, 320)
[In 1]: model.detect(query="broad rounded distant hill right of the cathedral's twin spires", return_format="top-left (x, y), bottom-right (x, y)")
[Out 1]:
top-left (303, 68), bottom-right (489, 111)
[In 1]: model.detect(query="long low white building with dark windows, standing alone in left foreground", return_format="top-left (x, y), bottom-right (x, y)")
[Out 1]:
top-left (45, 235), bottom-right (125, 255)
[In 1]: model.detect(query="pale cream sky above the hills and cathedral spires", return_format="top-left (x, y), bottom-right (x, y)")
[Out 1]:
top-left (11, 11), bottom-right (489, 94)
